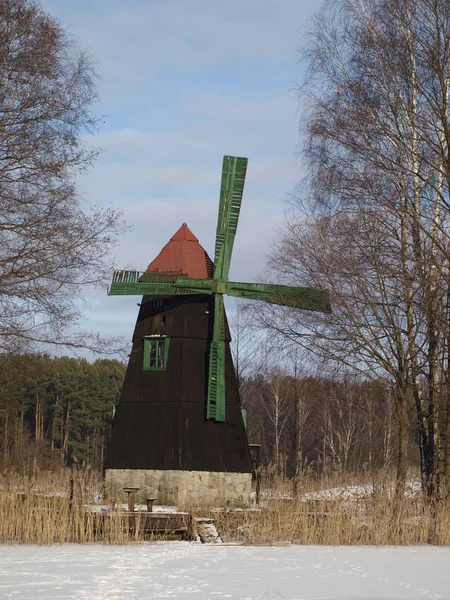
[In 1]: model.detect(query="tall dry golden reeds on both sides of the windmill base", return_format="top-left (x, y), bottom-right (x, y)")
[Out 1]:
top-left (0, 469), bottom-right (450, 546)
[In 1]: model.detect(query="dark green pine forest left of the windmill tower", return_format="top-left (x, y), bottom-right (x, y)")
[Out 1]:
top-left (0, 354), bottom-right (126, 472)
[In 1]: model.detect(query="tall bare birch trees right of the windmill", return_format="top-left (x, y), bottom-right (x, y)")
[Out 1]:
top-left (262, 0), bottom-right (450, 497)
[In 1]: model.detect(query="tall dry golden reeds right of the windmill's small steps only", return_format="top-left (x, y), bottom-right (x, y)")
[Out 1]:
top-left (209, 471), bottom-right (450, 546)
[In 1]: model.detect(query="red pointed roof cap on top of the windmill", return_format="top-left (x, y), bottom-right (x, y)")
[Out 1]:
top-left (146, 223), bottom-right (214, 279)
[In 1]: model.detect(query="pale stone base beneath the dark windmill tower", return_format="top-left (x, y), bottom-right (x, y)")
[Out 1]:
top-left (105, 469), bottom-right (252, 506)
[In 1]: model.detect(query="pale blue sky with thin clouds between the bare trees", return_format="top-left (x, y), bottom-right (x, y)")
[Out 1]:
top-left (41, 0), bottom-right (321, 356)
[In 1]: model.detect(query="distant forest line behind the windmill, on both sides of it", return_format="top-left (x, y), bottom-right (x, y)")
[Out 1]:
top-left (0, 346), bottom-right (404, 478)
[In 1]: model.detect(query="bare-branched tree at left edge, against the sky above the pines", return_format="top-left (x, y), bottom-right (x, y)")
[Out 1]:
top-left (0, 0), bottom-right (121, 350)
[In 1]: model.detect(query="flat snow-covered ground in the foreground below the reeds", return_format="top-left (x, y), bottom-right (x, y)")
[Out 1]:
top-left (0, 542), bottom-right (450, 600)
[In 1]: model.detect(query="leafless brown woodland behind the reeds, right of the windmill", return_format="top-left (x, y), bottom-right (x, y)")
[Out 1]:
top-left (242, 370), bottom-right (400, 478)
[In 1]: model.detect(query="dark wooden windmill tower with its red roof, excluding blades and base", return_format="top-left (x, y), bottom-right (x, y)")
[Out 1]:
top-left (105, 224), bottom-right (251, 473)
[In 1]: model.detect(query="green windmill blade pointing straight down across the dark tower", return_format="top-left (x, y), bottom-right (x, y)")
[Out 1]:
top-left (206, 294), bottom-right (225, 422)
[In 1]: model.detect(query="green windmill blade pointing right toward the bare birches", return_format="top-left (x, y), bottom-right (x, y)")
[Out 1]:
top-left (227, 281), bottom-right (331, 312)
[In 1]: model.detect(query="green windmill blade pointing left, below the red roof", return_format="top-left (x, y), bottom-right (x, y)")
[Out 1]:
top-left (108, 271), bottom-right (214, 296)
